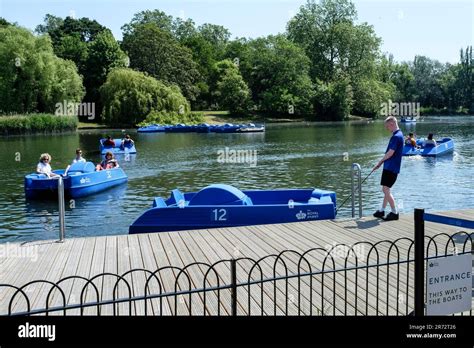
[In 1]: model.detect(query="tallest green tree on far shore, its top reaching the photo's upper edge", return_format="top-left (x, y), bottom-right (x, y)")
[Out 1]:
top-left (287, 0), bottom-right (384, 119)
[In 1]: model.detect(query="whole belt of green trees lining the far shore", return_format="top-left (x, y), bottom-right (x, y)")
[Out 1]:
top-left (0, 0), bottom-right (474, 125)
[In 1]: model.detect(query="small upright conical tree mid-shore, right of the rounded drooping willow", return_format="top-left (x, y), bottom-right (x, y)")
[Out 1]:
top-left (213, 59), bottom-right (250, 113)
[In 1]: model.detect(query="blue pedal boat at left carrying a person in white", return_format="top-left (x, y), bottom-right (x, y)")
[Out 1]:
top-left (24, 162), bottom-right (128, 199)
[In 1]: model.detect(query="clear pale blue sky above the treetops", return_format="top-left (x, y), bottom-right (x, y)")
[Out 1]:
top-left (0, 0), bottom-right (474, 63)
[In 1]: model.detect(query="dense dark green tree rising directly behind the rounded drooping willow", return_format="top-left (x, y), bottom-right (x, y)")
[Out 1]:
top-left (122, 23), bottom-right (200, 101)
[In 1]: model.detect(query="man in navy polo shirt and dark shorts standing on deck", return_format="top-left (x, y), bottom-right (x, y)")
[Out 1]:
top-left (372, 116), bottom-right (403, 221)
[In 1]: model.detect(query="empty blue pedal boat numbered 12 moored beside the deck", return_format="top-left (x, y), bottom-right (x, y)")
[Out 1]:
top-left (129, 184), bottom-right (336, 234)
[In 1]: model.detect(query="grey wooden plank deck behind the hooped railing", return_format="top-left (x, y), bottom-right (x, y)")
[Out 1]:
top-left (0, 209), bottom-right (474, 315)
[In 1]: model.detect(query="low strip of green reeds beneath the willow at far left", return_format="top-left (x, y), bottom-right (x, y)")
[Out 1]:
top-left (0, 114), bottom-right (78, 135)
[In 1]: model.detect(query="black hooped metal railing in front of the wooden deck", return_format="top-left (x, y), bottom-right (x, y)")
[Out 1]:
top-left (0, 209), bottom-right (473, 315)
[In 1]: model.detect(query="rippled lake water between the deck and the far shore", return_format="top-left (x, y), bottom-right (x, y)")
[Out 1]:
top-left (0, 117), bottom-right (474, 242)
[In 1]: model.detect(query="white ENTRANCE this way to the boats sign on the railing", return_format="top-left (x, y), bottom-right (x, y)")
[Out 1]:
top-left (426, 254), bottom-right (472, 315)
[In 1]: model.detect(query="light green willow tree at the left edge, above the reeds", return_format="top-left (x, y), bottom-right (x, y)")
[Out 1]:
top-left (0, 26), bottom-right (84, 113)
